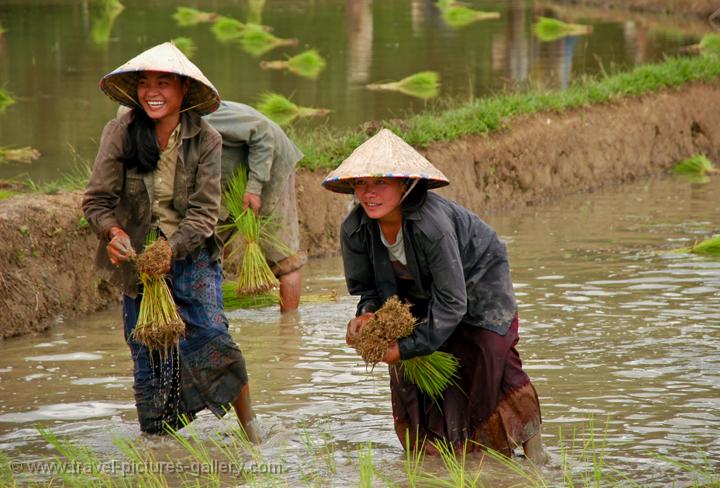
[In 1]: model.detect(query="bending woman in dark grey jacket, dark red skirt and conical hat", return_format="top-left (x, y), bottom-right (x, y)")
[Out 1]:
top-left (323, 129), bottom-right (545, 462)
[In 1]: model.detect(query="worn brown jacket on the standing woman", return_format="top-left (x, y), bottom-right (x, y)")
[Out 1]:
top-left (82, 108), bottom-right (222, 296)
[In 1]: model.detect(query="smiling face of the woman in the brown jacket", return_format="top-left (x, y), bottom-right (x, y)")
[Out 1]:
top-left (137, 71), bottom-right (188, 122)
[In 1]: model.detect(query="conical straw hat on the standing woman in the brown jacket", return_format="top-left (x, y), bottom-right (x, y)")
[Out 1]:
top-left (100, 42), bottom-right (220, 115)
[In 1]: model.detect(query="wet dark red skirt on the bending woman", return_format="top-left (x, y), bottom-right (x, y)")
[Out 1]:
top-left (390, 315), bottom-right (541, 456)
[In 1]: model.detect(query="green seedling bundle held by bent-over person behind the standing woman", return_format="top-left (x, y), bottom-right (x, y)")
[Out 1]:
top-left (220, 169), bottom-right (279, 296)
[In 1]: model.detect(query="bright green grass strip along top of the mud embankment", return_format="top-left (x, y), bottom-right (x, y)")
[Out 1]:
top-left (293, 56), bottom-right (720, 170)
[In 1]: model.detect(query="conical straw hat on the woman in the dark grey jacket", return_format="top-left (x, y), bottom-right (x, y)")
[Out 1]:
top-left (322, 129), bottom-right (450, 193)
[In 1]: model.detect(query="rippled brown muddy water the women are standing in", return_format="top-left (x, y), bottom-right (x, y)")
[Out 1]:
top-left (0, 175), bottom-right (720, 486)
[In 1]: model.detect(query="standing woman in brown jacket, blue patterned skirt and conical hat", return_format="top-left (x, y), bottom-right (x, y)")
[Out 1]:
top-left (82, 43), bottom-right (259, 442)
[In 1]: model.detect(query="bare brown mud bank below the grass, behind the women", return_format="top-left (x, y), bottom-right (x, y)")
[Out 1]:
top-left (0, 84), bottom-right (720, 338)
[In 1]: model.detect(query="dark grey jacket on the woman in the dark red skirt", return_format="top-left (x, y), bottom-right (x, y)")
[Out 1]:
top-left (341, 192), bottom-right (517, 359)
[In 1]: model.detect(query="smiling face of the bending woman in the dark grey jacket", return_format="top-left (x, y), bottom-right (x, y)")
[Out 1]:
top-left (353, 178), bottom-right (407, 220)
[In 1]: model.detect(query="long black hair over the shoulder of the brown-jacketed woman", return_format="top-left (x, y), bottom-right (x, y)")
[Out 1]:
top-left (120, 107), bottom-right (160, 173)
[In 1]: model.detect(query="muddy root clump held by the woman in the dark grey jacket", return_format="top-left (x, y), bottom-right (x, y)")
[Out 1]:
top-left (354, 296), bottom-right (416, 366)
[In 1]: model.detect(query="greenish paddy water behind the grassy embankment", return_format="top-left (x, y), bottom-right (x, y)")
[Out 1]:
top-left (0, 0), bottom-right (708, 182)
